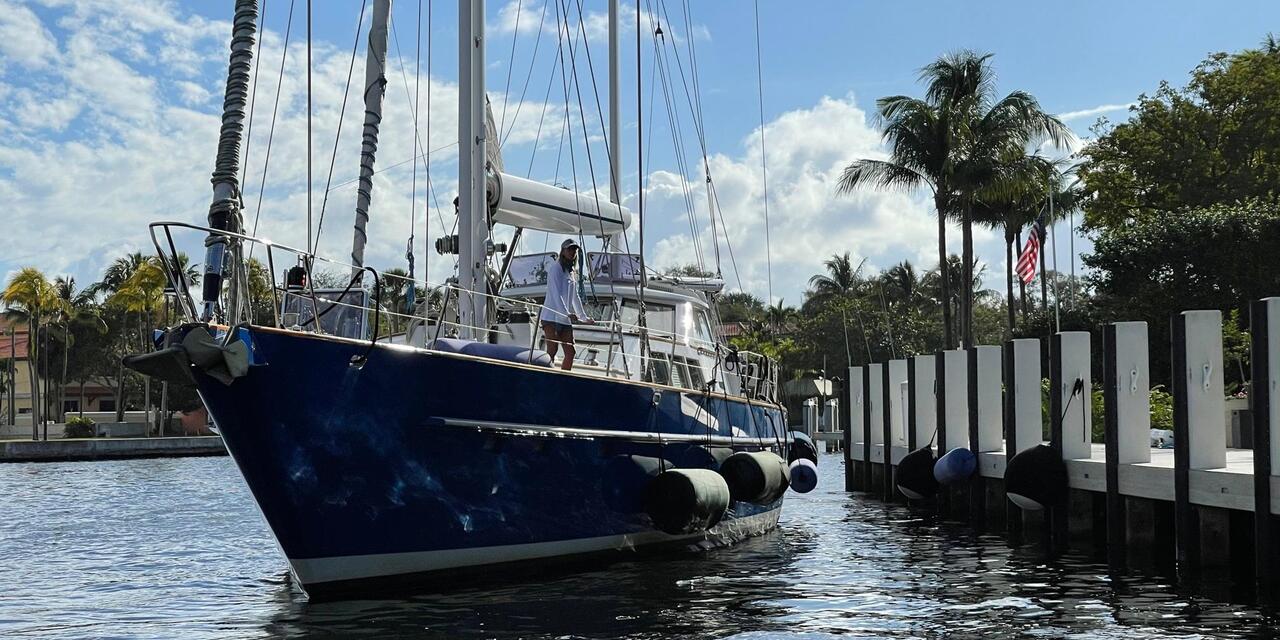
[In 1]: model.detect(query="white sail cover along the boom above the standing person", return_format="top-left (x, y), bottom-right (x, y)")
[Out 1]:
top-left (489, 173), bottom-right (631, 237)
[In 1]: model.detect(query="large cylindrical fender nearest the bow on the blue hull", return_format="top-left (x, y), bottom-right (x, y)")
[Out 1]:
top-left (644, 468), bottom-right (728, 535)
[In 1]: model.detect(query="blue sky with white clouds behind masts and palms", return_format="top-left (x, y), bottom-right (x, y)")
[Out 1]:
top-left (0, 0), bottom-right (1280, 305)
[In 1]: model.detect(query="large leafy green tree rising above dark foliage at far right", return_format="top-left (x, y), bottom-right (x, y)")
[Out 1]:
top-left (1079, 36), bottom-right (1280, 229)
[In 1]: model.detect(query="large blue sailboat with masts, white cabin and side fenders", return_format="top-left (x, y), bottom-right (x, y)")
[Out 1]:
top-left (127, 0), bottom-right (815, 596)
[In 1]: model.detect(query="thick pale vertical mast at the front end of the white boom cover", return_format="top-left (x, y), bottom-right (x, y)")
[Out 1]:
top-left (458, 0), bottom-right (489, 340)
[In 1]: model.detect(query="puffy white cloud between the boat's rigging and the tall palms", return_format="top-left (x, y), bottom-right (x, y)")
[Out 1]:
top-left (646, 96), bottom-right (1002, 303)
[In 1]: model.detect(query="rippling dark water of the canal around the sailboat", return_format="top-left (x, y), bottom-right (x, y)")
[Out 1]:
top-left (0, 456), bottom-right (1275, 639)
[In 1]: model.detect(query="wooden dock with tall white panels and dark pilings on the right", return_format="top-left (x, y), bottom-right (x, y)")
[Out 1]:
top-left (839, 298), bottom-right (1280, 600)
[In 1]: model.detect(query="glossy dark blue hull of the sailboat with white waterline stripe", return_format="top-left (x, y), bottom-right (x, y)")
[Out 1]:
top-left (197, 328), bottom-right (786, 590)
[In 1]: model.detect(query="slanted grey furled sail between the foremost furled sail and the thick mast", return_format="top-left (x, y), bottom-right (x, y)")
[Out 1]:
top-left (351, 0), bottom-right (389, 278)
